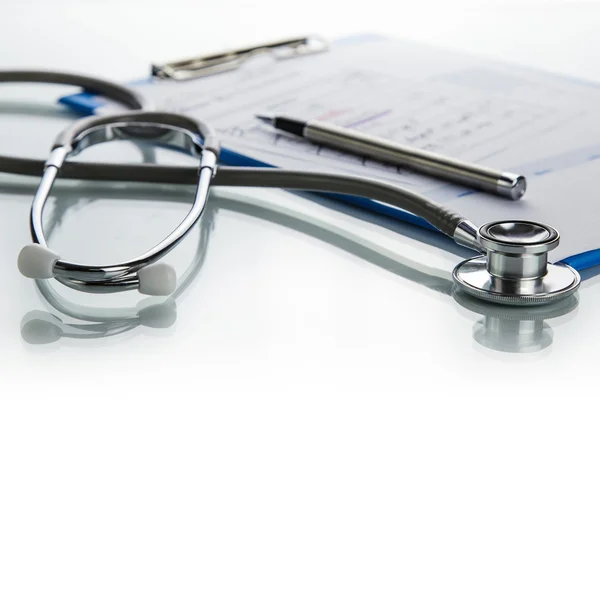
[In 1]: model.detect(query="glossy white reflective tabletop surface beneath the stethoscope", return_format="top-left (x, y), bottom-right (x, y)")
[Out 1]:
top-left (0, 2), bottom-right (600, 600)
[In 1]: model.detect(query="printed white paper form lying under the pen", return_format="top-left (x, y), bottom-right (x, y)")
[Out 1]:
top-left (83, 38), bottom-right (600, 257)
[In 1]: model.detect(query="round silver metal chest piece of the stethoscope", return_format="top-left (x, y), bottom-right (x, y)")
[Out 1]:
top-left (452, 221), bottom-right (581, 305)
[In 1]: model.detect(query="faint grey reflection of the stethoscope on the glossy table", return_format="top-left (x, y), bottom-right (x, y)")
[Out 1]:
top-left (0, 176), bottom-right (578, 353)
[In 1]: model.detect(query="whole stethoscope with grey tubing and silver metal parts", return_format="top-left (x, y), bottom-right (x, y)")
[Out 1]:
top-left (0, 71), bottom-right (580, 305)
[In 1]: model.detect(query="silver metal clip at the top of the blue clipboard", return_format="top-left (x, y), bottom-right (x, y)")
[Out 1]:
top-left (152, 35), bottom-right (329, 81)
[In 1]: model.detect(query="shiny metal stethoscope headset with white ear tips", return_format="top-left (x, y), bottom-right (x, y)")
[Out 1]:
top-left (18, 111), bottom-right (219, 296)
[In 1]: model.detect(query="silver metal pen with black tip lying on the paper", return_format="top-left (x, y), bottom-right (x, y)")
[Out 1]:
top-left (256, 115), bottom-right (527, 200)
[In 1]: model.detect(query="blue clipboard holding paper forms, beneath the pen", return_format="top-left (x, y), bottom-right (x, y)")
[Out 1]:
top-left (60, 35), bottom-right (600, 270)
